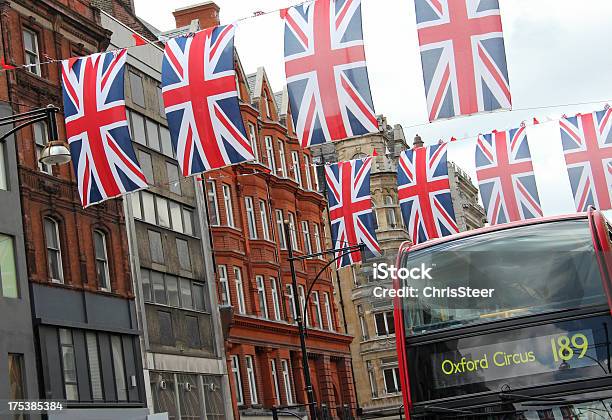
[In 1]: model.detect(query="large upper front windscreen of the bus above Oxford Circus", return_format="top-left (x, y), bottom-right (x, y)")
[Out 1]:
top-left (402, 219), bottom-right (607, 335)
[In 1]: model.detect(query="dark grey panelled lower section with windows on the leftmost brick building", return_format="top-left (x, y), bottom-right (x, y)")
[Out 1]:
top-left (32, 284), bottom-right (148, 419)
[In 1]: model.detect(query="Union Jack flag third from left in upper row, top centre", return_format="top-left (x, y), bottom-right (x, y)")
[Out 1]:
top-left (281, 0), bottom-right (378, 147)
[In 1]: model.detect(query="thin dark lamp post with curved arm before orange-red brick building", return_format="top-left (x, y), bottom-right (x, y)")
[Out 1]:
top-left (283, 220), bottom-right (364, 420)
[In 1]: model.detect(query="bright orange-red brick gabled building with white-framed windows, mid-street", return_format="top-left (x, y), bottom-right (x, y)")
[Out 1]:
top-left (167, 2), bottom-right (356, 417)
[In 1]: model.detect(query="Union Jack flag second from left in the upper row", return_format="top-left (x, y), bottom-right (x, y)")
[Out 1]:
top-left (162, 25), bottom-right (254, 176)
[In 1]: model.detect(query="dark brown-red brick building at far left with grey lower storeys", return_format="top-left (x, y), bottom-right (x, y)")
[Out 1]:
top-left (0, 0), bottom-right (147, 419)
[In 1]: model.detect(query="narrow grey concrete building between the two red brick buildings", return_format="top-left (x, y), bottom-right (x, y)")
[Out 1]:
top-left (101, 7), bottom-right (232, 419)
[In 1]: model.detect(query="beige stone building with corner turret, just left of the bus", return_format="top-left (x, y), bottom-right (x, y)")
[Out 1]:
top-left (314, 128), bottom-right (484, 418)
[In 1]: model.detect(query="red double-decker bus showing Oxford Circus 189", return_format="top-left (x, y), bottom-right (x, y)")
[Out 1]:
top-left (394, 210), bottom-right (612, 420)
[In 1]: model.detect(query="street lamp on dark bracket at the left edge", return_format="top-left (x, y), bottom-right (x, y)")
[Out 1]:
top-left (0, 105), bottom-right (71, 165)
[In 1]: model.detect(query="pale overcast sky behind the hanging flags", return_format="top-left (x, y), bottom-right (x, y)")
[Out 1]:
top-left (134, 0), bottom-right (612, 215)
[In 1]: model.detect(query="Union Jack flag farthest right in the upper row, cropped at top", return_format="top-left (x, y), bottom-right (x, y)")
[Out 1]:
top-left (415, 0), bottom-right (512, 121)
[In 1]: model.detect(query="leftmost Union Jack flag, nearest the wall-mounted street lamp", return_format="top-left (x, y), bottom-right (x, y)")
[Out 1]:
top-left (62, 49), bottom-right (147, 207)
